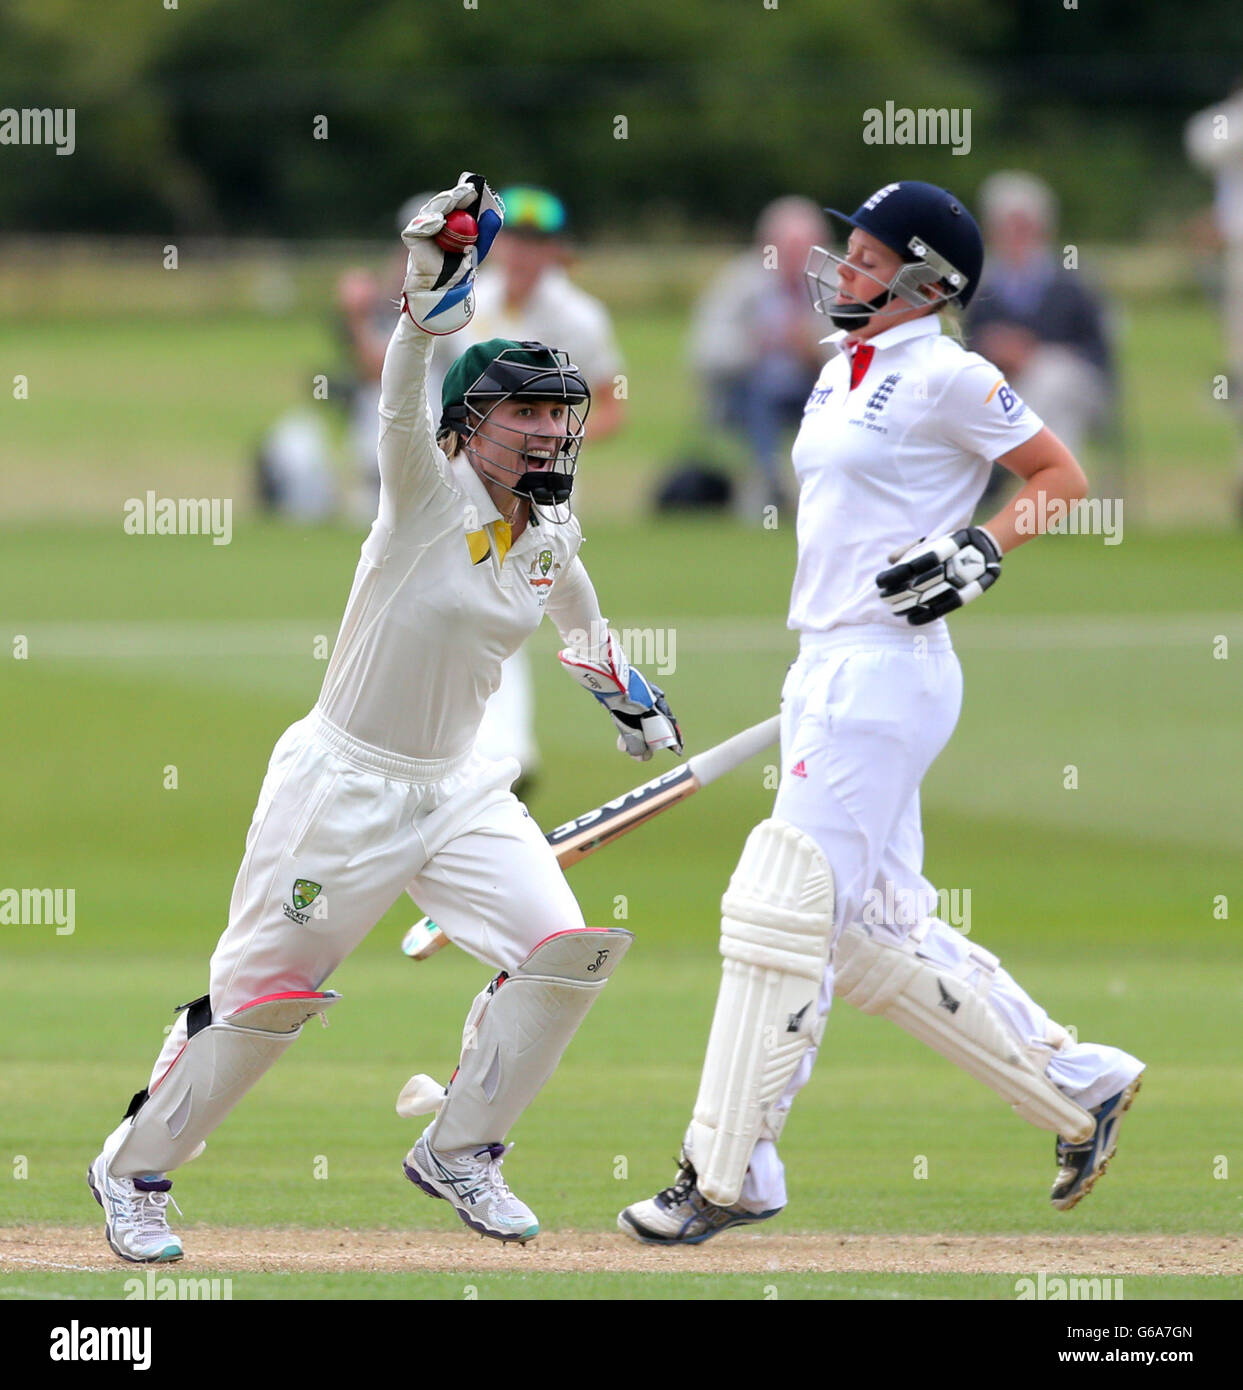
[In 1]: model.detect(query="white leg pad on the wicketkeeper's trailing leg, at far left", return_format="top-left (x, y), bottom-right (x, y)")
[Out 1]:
top-left (108, 990), bottom-right (341, 1177)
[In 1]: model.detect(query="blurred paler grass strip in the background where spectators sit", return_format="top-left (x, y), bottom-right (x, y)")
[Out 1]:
top-left (0, 291), bottom-right (1239, 528)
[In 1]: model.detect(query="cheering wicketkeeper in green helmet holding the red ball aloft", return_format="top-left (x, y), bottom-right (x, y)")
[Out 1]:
top-left (88, 174), bottom-right (681, 1262)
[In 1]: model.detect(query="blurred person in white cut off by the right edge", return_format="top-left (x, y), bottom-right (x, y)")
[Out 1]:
top-left (1186, 82), bottom-right (1243, 513)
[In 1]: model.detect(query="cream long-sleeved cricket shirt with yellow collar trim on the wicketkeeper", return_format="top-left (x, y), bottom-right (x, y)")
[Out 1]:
top-left (311, 314), bottom-right (603, 760)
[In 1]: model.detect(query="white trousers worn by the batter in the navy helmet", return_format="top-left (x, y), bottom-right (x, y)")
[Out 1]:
top-left (741, 623), bottom-right (1142, 1211)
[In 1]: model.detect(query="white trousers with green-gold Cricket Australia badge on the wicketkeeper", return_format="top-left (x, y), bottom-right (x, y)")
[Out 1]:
top-left (143, 708), bottom-right (583, 1088)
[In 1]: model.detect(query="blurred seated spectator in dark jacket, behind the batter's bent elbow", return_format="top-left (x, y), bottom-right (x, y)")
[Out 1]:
top-left (966, 171), bottom-right (1115, 467)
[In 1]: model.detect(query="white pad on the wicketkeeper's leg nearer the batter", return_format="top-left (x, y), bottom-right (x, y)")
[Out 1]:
top-left (431, 927), bottom-right (634, 1152)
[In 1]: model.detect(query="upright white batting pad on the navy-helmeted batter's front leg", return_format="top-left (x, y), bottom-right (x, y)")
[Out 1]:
top-left (685, 820), bottom-right (834, 1207)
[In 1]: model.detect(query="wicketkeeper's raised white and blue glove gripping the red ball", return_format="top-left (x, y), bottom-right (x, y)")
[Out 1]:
top-left (402, 172), bottom-right (505, 336)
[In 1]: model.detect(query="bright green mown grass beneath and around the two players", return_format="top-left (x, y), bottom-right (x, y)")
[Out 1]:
top-left (0, 523), bottom-right (1243, 1298)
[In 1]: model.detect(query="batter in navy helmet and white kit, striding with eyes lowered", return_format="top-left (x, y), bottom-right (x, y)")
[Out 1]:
top-left (617, 182), bottom-right (1143, 1244)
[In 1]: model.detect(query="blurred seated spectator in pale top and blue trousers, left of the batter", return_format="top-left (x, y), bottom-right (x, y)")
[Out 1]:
top-left (691, 197), bottom-right (829, 510)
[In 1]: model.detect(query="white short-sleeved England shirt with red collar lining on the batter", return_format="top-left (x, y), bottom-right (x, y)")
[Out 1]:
top-left (788, 316), bottom-right (1044, 632)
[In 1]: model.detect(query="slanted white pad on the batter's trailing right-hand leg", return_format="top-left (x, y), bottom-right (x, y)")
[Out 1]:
top-left (833, 926), bottom-right (1096, 1143)
